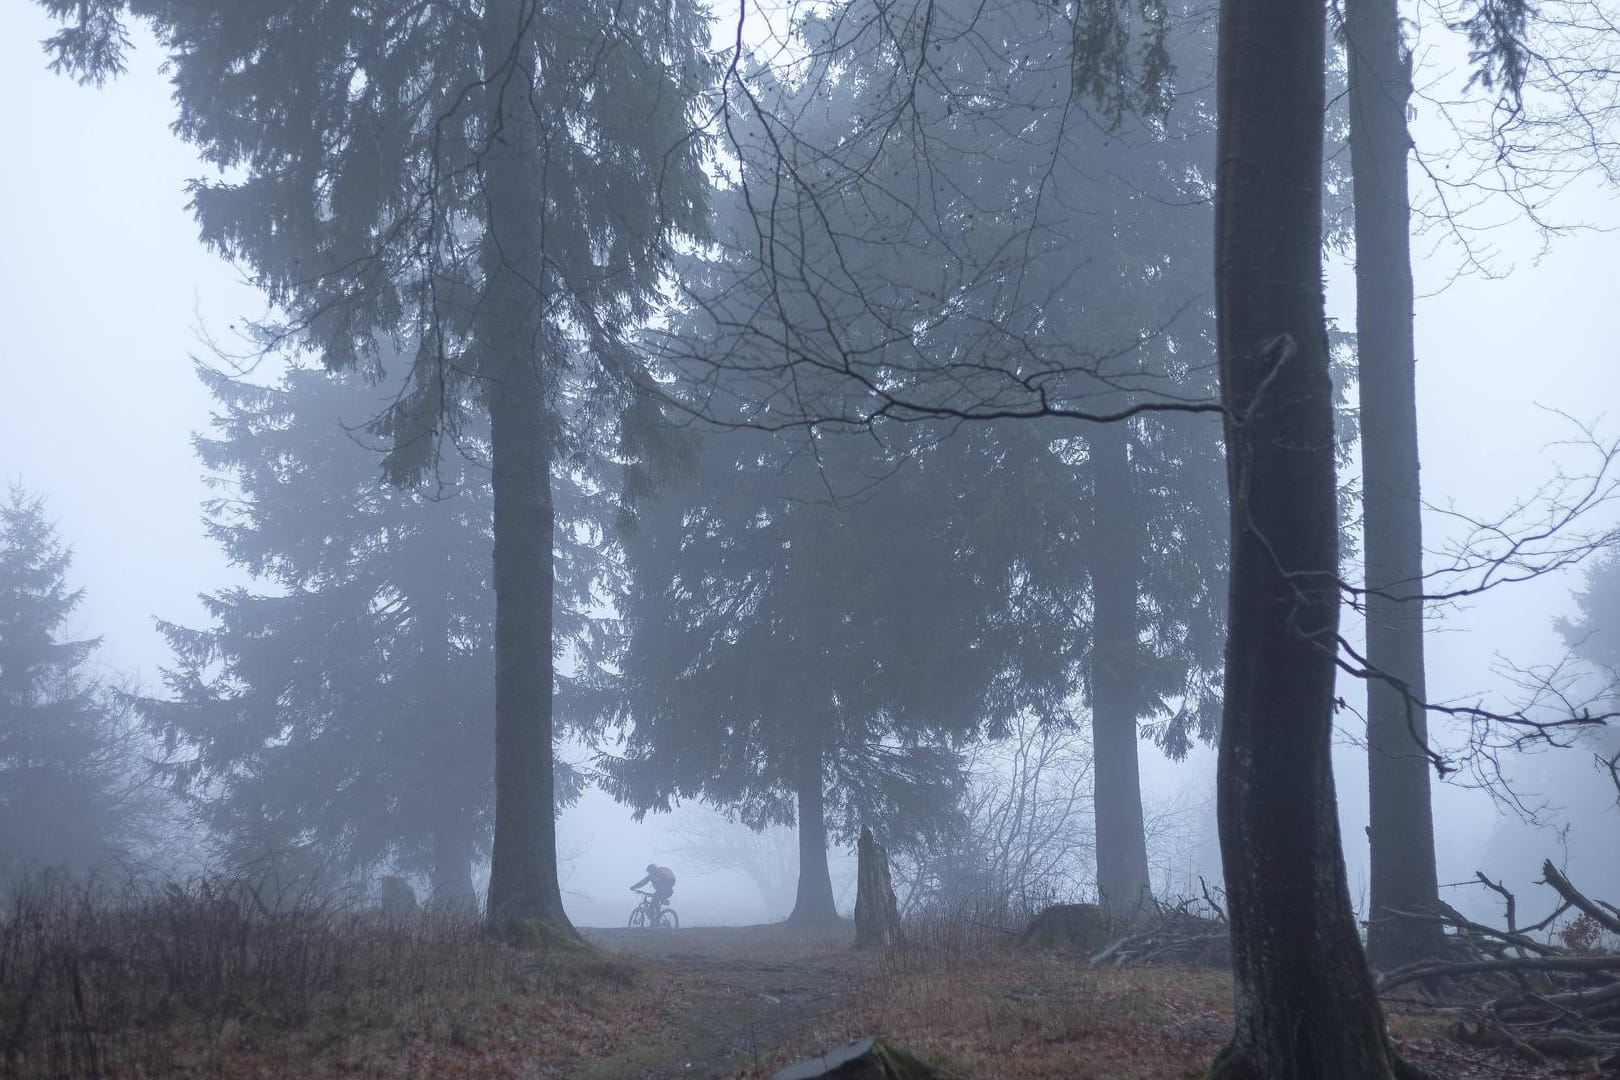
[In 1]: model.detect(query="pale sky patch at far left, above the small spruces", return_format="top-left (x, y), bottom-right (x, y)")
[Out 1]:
top-left (0, 3), bottom-right (262, 677)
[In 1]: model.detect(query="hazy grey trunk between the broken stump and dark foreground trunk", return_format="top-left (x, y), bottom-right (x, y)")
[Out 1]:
top-left (1089, 424), bottom-right (1149, 920)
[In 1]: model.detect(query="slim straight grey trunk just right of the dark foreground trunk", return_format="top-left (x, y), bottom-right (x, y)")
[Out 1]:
top-left (1345, 0), bottom-right (1443, 968)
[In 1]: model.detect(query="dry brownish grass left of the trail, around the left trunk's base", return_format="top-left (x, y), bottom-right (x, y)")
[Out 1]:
top-left (0, 878), bottom-right (666, 1078)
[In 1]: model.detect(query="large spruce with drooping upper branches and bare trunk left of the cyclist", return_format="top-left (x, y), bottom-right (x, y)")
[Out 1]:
top-left (42, 0), bottom-right (708, 928)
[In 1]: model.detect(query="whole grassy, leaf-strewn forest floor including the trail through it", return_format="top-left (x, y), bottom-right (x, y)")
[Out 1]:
top-left (0, 891), bottom-right (1599, 1080)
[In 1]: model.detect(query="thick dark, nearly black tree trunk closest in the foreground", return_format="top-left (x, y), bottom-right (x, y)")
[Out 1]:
top-left (1212, 0), bottom-right (1396, 1080)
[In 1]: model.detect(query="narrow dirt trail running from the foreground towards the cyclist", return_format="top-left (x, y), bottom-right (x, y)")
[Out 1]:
top-left (578, 926), bottom-right (868, 1080)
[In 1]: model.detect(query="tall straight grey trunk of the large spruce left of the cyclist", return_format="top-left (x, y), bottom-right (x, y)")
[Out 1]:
top-left (475, 0), bottom-right (573, 934)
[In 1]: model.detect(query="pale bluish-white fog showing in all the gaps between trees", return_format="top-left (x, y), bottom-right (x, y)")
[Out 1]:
top-left (0, 5), bottom-right (1620, 926)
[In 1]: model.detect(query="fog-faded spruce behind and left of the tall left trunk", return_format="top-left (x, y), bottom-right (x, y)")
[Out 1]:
top-left (141, 368), bottom-right (494, 907)
